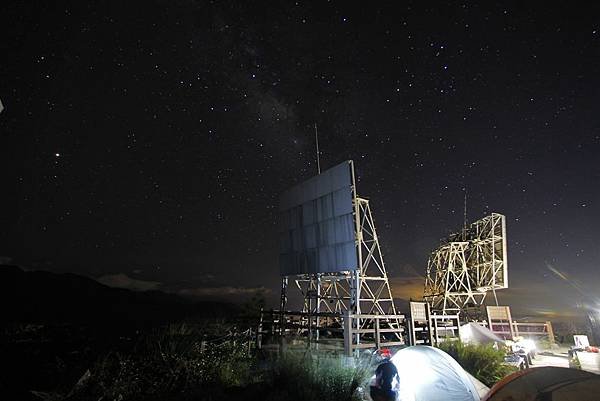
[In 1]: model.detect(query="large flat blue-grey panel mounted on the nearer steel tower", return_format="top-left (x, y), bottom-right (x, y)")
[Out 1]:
top-left (279, 161), bottom-right (358, 276)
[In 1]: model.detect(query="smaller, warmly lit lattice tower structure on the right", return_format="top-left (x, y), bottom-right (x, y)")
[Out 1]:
top-left (424, 213), bottom-right (508, 315)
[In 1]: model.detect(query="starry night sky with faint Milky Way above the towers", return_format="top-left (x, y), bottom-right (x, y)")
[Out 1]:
top-left (0, 0), bottom-right (600, 317)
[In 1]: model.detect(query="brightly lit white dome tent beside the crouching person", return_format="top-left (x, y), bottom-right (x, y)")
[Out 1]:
top-left (368, 345), bottom-right (480, 401)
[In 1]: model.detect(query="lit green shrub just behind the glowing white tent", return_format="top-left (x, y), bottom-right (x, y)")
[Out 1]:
top-left (439, 341), bottom-right (516, 387)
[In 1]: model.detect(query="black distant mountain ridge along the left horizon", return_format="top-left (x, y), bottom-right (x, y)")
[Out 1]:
top-left (0, 266), bottom-right (237, 326)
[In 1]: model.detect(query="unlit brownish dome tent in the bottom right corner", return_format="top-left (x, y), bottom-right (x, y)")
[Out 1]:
top-left (484, 366), bottom-right (600, 401)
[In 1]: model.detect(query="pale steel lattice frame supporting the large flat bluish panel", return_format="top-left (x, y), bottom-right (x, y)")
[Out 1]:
top-left (280, 161), bottom-right (400, 342)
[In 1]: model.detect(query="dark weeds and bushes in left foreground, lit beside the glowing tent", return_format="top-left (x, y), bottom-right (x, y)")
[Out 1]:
top-left (51, 325), bottom-right (373, 401)
